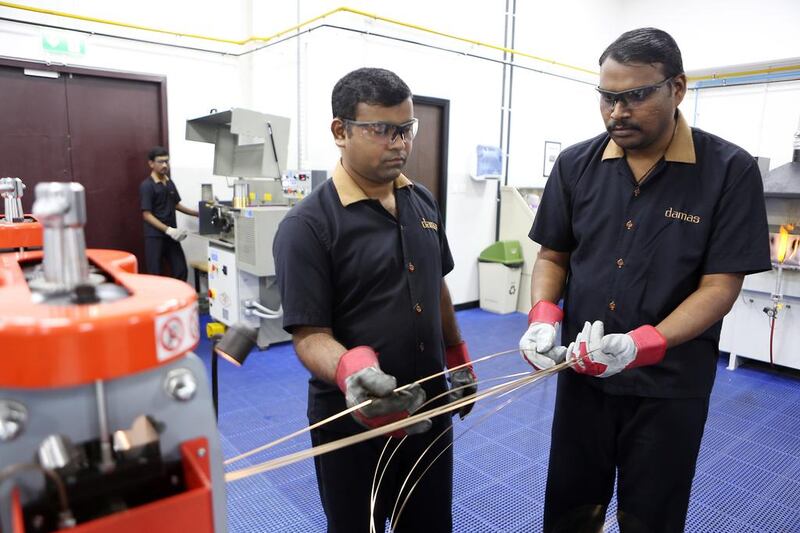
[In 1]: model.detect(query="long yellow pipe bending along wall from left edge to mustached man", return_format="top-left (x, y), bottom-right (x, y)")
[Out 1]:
top-left (0, 2), bottom-right (597, 75)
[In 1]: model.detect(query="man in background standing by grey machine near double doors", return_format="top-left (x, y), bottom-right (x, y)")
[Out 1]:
top-left (139, 146), bottom-right (198, 281)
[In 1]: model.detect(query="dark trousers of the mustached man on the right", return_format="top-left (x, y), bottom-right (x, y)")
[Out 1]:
top-left (544, 371), bottom-right (708, 533)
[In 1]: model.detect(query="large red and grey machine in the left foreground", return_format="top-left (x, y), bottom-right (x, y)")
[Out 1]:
top-left (0, 183), bottom-right (226, 533)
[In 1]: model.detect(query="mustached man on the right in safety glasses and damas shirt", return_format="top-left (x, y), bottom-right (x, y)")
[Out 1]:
top-left (520, 28), bottom-right (770, 533)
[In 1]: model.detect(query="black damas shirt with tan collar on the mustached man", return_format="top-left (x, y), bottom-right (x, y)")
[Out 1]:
top-left (530, 114), bottom-right (771, 397)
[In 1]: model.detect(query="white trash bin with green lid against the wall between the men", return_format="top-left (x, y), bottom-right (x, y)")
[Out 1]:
top-left (478, 241), bottom-right (524, 314)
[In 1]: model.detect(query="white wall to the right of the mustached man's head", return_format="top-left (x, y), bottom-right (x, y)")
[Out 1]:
top-left (620, 0), bottom-right (800, 172)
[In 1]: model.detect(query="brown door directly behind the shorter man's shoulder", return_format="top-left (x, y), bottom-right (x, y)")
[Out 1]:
top-left (403, 96), bottom-right (450, 219)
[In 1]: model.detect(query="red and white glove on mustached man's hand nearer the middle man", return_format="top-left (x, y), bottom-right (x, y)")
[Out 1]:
top-left (519, 300), bottom-right (567, 370)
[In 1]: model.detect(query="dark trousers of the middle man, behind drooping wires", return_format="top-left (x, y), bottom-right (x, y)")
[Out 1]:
top-left (311, 415), bottom-right (453, 533)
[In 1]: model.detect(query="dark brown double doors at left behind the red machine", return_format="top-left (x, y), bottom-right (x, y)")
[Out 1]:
top-left (0, 60), bottom-right (167, 265)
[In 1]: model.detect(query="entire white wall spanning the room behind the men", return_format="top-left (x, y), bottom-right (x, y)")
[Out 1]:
top-left (0, 0), bottom-right (800, 303)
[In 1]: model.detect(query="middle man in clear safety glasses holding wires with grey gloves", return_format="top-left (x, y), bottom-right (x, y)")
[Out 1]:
top-left (273, 68), bottom-right (477, 533)
